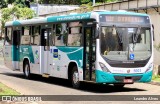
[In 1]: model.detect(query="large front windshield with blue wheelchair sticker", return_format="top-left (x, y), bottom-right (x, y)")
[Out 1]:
top-left (100, 26), bottom-right (151, 61)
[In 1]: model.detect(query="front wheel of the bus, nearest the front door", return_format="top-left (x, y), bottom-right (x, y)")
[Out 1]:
top-left (71, 66), bottom-right (80, 88)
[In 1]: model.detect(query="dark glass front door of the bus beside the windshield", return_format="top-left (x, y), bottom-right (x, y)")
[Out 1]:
top-left (83, 26), bottom-right (95, 81)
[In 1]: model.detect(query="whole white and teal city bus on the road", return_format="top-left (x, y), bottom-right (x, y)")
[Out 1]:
top-left (4, 11), bottom-right (153, 88)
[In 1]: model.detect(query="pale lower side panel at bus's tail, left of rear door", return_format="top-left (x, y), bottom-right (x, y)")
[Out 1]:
top-left (4, 45), bottom-right (14, 70)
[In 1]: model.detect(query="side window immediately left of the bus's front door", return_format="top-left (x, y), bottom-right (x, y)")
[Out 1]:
top-left (67, 22), bottom-right (82, 46)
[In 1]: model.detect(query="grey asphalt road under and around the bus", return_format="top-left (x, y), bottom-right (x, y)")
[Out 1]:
top-left (0, 66), bottom-right (160, 104)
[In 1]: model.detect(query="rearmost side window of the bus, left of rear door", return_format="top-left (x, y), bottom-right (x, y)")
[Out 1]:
top-left (4, 27), bottom-right (12, 45)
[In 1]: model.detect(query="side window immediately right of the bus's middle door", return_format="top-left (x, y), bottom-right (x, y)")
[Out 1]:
top-left (55, 23), bottom-right (68, 46)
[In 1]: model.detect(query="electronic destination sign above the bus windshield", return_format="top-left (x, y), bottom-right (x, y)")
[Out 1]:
top-left (100, 15), bottom-right (149, 23)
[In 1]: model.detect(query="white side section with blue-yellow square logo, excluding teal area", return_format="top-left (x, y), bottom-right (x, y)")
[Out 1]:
top-left (49, 46), bottom-right (70, 79)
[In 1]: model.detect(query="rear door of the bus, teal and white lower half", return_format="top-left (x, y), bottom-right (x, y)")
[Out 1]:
top-left (12, 30), bottom-right (21, 70)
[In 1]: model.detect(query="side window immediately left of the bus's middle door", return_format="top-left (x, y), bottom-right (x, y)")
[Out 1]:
top-left (31, 26), bottom-right (40, 45)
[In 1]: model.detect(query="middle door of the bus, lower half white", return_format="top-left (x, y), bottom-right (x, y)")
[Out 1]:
top-left (40, 28), bottom-right (51, 77)
